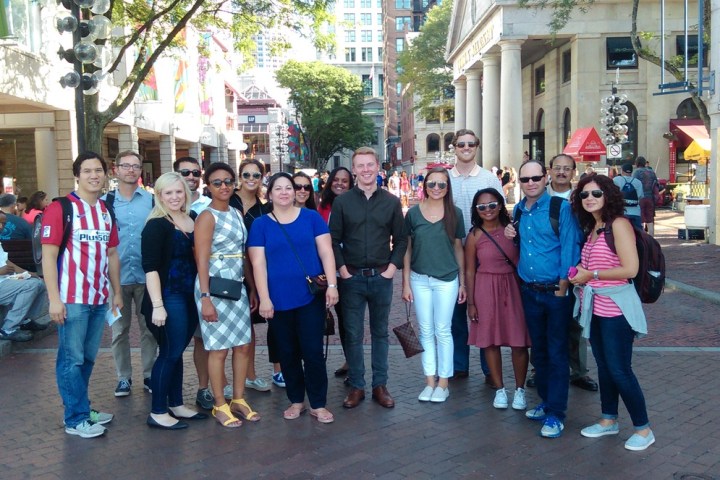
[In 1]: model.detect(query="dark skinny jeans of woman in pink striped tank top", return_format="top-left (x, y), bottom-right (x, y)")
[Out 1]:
top-left (590, 315), bottom-right (648, 430)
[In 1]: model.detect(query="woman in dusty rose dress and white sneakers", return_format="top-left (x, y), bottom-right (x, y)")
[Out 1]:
top-left (465, 188), bottom-right (530, 410)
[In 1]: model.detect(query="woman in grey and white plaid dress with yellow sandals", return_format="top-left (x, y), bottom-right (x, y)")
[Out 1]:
top-left (195, 162), bottom-right (260, 427)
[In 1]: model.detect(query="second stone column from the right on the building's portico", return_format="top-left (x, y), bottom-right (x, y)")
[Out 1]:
top-left (482, 55), bottom-right (500, 170)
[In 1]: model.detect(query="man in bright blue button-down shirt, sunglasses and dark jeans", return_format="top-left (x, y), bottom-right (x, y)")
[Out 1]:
top-left (505, 160), bottom-right (582, 438)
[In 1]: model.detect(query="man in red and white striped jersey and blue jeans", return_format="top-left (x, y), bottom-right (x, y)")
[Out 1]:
top-left (41, 152), bottom-right (123, 438)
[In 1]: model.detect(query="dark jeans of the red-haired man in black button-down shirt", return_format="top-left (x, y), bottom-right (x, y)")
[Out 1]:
top-left (339, 275), bottom-right (393, 389)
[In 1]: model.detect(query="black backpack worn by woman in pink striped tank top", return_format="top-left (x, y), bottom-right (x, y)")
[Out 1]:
top-left (605, 218), bottom-right (665, 303)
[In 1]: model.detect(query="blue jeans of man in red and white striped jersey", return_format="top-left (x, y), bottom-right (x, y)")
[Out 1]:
top-left (55, 303), bottom-right (108, 428)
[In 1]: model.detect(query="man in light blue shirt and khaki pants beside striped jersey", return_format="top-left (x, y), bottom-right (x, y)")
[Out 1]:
top-left (103, 151), bottom-right (157, 397)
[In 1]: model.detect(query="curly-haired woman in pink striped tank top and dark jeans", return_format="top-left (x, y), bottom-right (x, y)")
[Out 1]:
top-left (570, 175), bottom-right (655, 451)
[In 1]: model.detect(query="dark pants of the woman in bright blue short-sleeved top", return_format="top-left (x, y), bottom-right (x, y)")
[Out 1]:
top-left (268, 295), bottom-right (328, 408)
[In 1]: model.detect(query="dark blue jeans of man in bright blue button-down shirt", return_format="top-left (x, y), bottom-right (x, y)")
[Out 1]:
top-left (521, 286), bottom-right (573, 420)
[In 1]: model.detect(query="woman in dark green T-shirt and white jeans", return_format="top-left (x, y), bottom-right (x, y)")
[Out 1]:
top-left (402, 168), bottom-right (466, 402)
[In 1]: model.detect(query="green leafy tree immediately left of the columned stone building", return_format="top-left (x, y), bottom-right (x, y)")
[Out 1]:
top-left (398, 0), bottom-right (455, 118)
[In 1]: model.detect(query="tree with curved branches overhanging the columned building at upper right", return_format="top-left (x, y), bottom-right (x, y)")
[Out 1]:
top-left (518, 0), bottom-right (711, 132)
